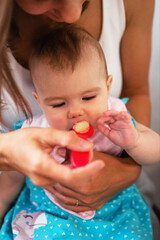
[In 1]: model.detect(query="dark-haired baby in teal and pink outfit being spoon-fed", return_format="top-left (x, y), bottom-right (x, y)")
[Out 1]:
top-left (0, 25), bottom-right (159, 240)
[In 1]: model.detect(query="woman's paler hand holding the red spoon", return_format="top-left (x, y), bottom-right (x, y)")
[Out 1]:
top-left (0, 128), bottom-right (104, 187)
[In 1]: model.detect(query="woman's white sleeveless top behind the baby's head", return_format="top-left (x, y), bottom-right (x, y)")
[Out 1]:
top-left (0, 0), bottom-right (126, 132)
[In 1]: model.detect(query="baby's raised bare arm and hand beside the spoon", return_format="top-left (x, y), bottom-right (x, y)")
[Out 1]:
top-left (97, 110), bottom-right (160, 165)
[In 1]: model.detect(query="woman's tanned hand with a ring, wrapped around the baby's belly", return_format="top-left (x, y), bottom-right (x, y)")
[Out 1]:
top-left (47, 152), bottom-right (141, 212)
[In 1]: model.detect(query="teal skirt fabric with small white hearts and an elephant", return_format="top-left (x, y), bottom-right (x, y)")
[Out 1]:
top-left (0, 178), bottom-right (153, 240)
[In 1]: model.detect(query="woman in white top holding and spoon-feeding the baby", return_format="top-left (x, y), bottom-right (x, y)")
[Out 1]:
top-left (0, 0), bottom-right (154, 223)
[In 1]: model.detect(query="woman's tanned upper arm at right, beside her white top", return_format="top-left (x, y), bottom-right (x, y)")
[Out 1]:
top-left (120, 0), bottom-right (154, 126)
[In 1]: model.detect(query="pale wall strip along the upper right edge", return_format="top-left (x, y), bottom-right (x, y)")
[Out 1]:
top-left (149, 0), bottom-right (160, 134)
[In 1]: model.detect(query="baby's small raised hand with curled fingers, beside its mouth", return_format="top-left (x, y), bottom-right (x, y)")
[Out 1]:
top-left (97, 110), bottom-right (138, 149)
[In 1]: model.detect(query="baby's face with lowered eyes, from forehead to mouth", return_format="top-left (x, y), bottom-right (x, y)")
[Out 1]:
top-left (32, 55), bottom-right (110, 130)
